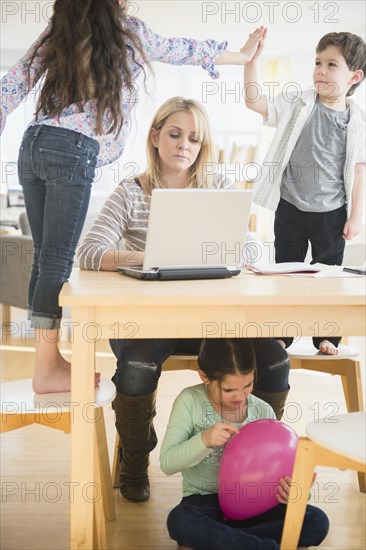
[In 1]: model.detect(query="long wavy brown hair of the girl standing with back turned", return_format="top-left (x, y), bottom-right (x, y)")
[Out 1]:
top-left (28, 0), bottom-right (148, 135)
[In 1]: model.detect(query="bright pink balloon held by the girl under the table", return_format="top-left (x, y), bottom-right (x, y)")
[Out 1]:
top-left (218, 419), bottom-right (298, 520)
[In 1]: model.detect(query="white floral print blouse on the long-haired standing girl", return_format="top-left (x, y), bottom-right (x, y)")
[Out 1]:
top-left (0, 17), bottom-right (227, 166)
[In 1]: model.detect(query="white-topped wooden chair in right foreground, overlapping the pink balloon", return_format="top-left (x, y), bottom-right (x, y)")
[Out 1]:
top-left (281, 412), bottom-right (366, 550)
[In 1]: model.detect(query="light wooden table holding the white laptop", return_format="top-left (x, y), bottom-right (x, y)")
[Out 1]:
top-left (60, 270), bottom-right (365, 550)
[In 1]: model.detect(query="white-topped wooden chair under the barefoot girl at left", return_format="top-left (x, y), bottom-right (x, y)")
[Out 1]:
top-left (0, 377), bottom-right (116, 548)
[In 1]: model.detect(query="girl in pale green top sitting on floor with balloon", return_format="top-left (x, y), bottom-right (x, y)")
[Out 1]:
top-left (160, 338), bottom-right (329, 550)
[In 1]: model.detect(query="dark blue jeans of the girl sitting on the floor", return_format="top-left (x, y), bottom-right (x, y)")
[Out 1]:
top-left (167, 494), bottom-right (329, 550)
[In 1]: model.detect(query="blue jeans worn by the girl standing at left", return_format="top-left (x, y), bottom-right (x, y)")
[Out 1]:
top-left (18, 125), bottom-right (99, 329)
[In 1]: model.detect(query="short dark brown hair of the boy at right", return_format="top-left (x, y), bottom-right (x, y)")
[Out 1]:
top-left (316, 32), bottom-right (366, 96)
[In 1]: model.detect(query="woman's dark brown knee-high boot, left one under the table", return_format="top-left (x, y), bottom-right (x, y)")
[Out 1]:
top-left (113, 392), bottom-right (158, 502)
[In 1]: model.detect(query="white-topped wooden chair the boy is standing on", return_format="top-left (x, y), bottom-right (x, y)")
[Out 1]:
top-left (287, 339), bottom-right (366, 493)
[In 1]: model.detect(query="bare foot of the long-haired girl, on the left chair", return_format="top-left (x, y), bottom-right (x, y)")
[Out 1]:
top-left (33, 355), bottom-right (100, 393)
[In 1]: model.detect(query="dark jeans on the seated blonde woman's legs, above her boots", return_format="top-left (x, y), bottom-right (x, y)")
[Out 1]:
top-left (109, 338), bottom-right (290, 397)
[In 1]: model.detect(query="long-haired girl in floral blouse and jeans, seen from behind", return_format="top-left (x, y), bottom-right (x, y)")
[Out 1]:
top-left (0, 0), bottom-right (262, 393)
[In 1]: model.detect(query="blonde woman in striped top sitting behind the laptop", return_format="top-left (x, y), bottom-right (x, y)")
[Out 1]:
top-left (77, 97), bottom-right (289, 502)
